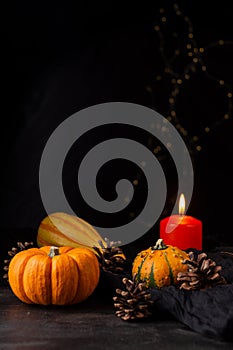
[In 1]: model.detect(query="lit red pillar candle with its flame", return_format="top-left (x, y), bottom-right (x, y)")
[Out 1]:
top-left (160, 194), bottom-right (202, 250)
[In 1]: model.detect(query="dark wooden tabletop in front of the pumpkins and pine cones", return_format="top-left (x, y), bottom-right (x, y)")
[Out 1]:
top-left (0, 286), bottom-right (233, 350)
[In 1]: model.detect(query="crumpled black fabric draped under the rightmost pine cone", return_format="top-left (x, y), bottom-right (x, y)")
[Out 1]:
top-left (152, 284), bottom-right (233, 341)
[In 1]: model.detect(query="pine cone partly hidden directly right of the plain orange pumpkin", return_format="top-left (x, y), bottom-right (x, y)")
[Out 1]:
top-left (94, 238), bottom-right (126, 273)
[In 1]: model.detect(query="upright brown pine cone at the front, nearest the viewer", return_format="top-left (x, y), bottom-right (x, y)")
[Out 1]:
top-left (113, 275), bottom-right (153, 321)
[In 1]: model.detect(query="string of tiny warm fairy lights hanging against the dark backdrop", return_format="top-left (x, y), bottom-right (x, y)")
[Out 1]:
top-left (147, 3), bottom-right (233, 154)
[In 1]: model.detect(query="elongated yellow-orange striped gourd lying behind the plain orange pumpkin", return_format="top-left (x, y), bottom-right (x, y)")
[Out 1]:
top-left (37, 212), bottom-right (106, 253)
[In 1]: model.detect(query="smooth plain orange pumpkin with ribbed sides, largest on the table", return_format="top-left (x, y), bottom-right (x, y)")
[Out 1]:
top-left (8, 246), bottom-right (100, 305)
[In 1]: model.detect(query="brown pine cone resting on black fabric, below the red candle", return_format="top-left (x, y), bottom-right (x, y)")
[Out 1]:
top-left (177, 252), bottom-right (227, 290)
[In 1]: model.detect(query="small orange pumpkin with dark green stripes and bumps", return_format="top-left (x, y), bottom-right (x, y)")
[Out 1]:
top-left (132, 239), bottom-right (189, 288)
